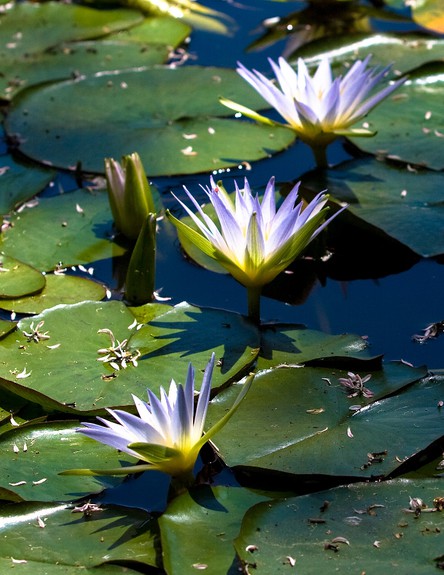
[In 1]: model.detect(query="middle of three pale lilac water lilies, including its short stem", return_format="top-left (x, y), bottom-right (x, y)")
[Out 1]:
top-left (167, 178), bottom-right (339, 321)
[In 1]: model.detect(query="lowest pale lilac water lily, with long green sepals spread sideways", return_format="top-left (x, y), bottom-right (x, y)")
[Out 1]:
top-left (62, 353), bottom-right (252, 484)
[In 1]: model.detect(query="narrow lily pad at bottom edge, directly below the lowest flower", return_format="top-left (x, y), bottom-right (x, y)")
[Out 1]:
top-left (159, 485), bottom-right (268, 575)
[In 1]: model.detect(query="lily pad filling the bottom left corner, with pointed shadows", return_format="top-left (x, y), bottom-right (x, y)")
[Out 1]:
top-left (0, 502), bottom-right (159, 575)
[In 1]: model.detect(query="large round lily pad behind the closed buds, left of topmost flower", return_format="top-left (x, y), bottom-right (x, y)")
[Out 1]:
top-left (5, 66), bottom-right (295, 176)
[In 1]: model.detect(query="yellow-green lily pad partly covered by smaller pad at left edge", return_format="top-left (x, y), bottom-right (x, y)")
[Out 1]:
top-left (0, 274), bottom-right (106, 314)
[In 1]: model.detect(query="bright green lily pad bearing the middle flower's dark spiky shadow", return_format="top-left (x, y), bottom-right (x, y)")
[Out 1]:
top-left (0, 301), bottom-right (259, 413)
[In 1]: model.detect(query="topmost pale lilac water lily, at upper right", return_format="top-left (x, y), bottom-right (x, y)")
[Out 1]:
top-left (221, 56), bottom-right (405, 166)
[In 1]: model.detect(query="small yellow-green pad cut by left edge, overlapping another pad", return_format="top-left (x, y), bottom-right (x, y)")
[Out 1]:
top-left (0, 253), bottom-right (46, 307)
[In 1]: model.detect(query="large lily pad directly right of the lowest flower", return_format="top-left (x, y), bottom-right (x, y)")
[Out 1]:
top-left (207, 363), bottom-right (430, 486)
